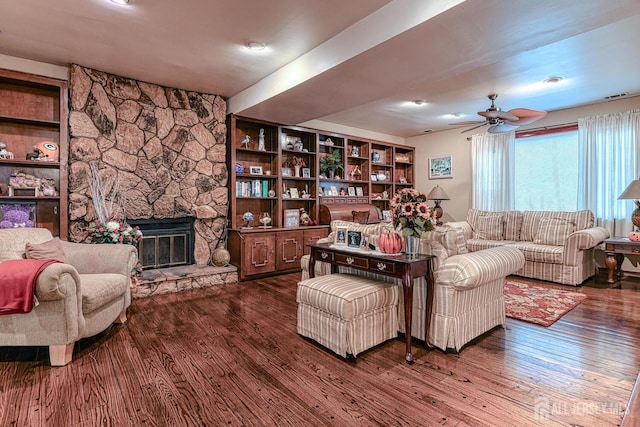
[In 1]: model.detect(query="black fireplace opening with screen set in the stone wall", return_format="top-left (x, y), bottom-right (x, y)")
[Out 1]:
top-left (129, 218), bottom-right (194, 269)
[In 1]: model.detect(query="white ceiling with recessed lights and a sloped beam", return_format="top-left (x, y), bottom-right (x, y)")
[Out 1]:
top-left (0, 0), bottom-right (640, 137)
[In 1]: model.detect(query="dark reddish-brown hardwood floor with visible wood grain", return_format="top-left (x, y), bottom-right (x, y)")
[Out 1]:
top-left (0, 273), bottom-right (640, 426)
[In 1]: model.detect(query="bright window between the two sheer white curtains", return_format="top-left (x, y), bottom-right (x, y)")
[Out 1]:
top-left (514, 126), bottom-right (578, 211)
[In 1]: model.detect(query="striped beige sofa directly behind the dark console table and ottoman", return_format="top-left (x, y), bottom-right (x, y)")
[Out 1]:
top-left (301, 221), bottom-right (525, 351)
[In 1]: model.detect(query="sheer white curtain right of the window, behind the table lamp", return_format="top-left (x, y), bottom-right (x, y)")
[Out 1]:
top-left (578, 110), bottom-right (640, 236)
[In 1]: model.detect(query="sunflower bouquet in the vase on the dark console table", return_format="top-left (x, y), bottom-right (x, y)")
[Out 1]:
top-left (391, 188), bottom-right (433, 237)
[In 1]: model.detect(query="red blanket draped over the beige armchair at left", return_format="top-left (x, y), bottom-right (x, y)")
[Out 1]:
top-left (0, 259), bottom-right (60, 314)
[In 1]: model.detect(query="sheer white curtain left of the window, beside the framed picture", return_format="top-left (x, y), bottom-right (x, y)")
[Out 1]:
top-left (471, 131), bottom-right (516, 211)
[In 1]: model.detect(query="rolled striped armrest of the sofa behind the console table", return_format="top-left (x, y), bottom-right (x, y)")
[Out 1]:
top-left (434, 246), bottom-right (525, 289)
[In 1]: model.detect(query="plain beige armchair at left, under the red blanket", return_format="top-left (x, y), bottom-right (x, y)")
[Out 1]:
top-left (0, 228), bottom-right (137, 366)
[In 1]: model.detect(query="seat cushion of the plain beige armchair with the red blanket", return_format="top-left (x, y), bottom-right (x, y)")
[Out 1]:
top-left (80, 273), bottom-right (130, 314)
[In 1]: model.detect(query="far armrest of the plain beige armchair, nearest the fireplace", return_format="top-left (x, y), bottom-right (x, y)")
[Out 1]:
top-left (60, 241), bottom-right (138, 276)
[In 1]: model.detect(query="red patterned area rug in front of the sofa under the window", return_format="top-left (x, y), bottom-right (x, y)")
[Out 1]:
top-left (504, 279), bottom-right (587, 326)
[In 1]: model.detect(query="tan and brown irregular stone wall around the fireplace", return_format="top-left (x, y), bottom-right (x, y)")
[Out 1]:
top-left (68, 65), bottom-right (229, 265)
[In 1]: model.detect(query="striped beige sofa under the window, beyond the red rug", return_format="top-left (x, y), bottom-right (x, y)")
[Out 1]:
top-left (448, 209), bottom-right (609, 286)
